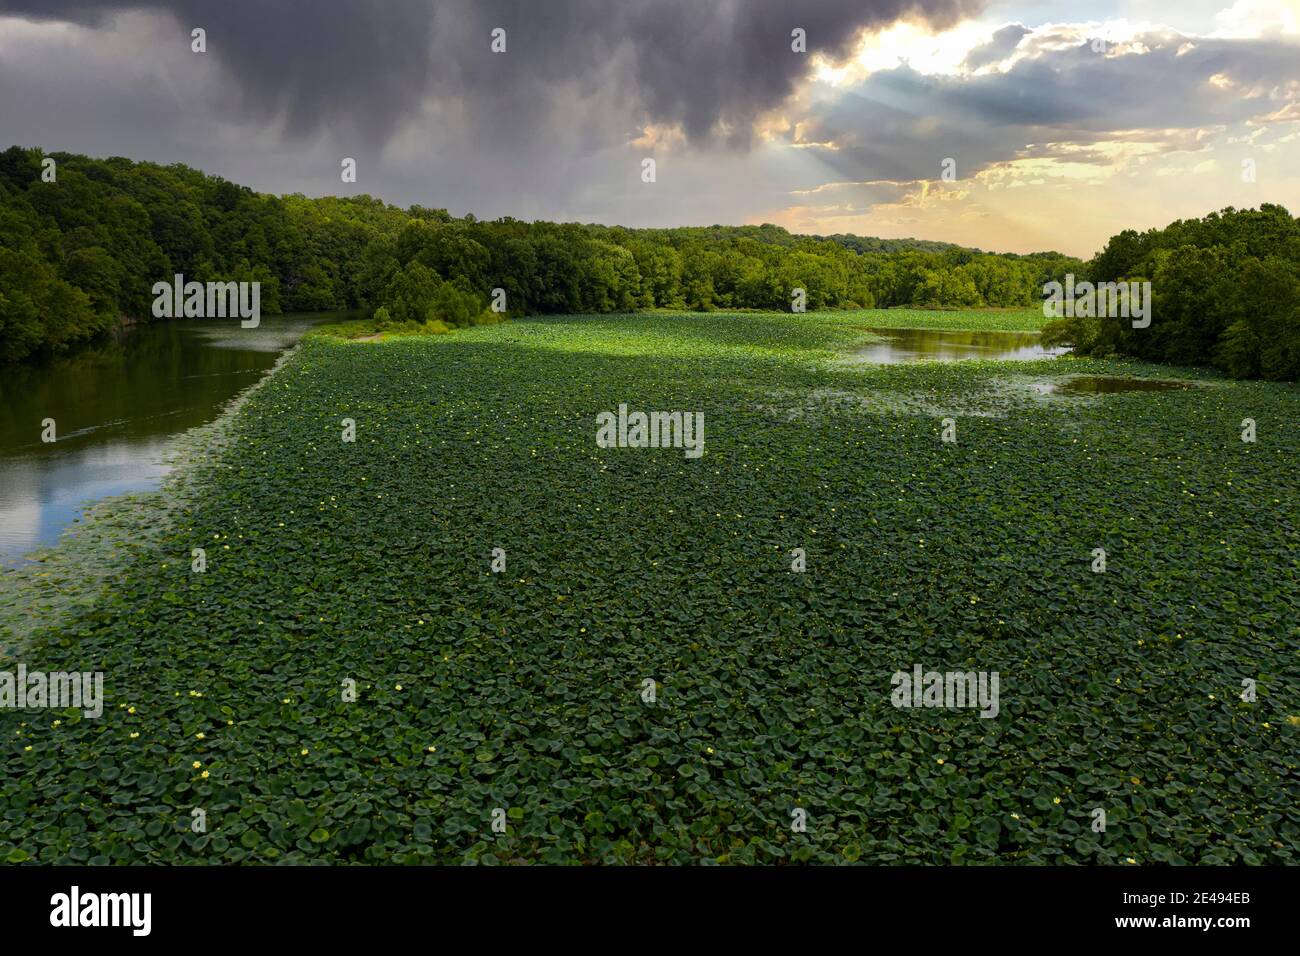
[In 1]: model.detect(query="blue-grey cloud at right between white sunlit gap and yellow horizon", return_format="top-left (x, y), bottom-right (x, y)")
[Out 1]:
top-left (780, 26), bottom-right (1300, 182)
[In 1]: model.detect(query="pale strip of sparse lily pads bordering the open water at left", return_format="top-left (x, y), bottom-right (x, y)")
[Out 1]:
top-left (0, 342), bottom-right (302, 662)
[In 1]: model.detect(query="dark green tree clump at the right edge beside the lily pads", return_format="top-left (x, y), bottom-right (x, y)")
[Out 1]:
top-left (1044, 204), bottom-right (1300, 381)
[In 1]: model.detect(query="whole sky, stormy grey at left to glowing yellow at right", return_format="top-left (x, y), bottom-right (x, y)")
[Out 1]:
top-left (0, 0), bottom-right (1300, 258)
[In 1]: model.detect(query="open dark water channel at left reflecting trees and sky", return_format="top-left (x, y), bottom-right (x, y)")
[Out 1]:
top-left (0, 312), bottom-right (339, 564)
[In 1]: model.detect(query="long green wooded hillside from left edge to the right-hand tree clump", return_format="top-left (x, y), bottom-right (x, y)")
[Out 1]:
top-left (0, 147), bottom-right (1082, 360)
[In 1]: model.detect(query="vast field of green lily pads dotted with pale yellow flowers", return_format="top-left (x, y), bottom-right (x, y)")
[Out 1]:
top-left (0, 311), bottom-right (1300, 865)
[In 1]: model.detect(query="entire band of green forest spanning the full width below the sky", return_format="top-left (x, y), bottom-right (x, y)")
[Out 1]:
top-left (0, 146), bottom-right (1300, 380)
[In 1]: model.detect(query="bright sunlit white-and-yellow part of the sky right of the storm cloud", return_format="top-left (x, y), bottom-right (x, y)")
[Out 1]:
top-left (751, 21), bottom-right (1300, 255)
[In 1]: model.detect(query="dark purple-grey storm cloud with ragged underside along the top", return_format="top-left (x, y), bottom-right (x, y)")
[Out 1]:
top-left (0, 0), bottom-right (983, 144)
